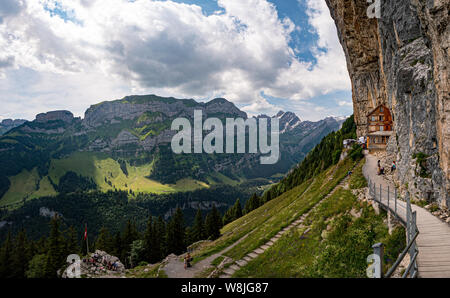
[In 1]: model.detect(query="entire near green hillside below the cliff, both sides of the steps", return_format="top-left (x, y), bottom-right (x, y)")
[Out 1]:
top-left (188, 118), bottom-right (405, 277)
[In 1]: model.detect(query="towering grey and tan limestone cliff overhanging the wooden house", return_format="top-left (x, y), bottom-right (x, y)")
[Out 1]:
top-left (326, 0), bottom-right (450, 206)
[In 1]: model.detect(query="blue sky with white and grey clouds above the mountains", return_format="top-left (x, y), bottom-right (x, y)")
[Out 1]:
top-left (0, 0), bottom-right (352, 120)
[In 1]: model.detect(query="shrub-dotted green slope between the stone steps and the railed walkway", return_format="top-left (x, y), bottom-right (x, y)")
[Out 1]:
top-left (233, 161), bottom-right (405, 278)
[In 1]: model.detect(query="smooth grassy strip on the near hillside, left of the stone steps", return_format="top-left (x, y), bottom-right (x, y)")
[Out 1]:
top-left (192, 159), bottom-right (354, 260)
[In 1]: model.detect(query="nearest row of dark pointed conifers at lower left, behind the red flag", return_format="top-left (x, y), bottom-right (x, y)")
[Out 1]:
top-left (0, 206), bottom-right (223, 278)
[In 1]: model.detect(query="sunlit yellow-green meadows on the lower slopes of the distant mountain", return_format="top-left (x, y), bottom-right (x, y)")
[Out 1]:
top-left (0, 152), bottom-right (213, 207)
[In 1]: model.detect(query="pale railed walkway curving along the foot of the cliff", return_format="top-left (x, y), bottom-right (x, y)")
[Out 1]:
top-left (363, 154), bottom-right (450, 278)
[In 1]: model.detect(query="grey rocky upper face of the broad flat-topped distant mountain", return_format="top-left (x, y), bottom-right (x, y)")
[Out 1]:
top-left (82, 95), bottom-right (247, 152)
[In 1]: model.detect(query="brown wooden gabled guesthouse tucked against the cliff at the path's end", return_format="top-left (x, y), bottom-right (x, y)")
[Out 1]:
top-left (367, 105), bottom-right (393, 151)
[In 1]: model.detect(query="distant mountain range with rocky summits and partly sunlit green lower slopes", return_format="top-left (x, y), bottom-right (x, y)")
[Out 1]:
top-left (0, 95), bottom-right (343, 206)
